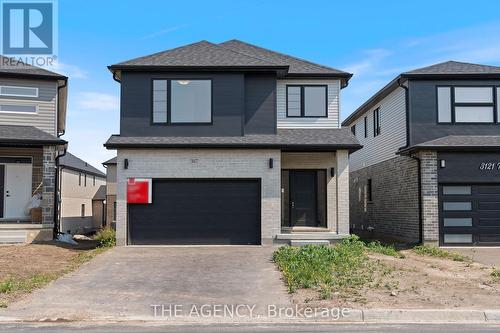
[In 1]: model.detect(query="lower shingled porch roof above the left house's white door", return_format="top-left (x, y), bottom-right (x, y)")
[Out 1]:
top-left (0, 125), bottom-right (66, 146)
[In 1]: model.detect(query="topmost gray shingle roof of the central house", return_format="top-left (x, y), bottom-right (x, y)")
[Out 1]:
top-left (110, 40), bottom-right (352, 79)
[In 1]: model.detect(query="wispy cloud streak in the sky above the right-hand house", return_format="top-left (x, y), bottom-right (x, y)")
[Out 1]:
top-left (339, 22), bottom-right (500, 118)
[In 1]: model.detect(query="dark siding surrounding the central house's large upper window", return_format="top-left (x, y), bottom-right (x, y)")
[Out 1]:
top-left (120, 72), bottom-right (244, 136)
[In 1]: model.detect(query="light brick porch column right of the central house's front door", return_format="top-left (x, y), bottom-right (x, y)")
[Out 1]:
top-left (336, 150), bottom-right (349, 235)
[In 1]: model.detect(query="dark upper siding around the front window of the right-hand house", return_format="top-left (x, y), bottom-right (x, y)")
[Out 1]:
top-left (409, 80), bottom-right (500, 145)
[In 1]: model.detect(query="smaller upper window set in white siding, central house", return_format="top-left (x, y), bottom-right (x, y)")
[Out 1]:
top-left (286, 85), bottom-right (328, 118)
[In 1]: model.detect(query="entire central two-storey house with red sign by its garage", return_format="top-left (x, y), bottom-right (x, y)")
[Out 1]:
top-left (105, 40), bottom-right (360, 245)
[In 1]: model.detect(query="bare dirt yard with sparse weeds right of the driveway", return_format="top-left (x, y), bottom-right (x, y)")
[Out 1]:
top-left (278, 237), bottom-right (500, 309)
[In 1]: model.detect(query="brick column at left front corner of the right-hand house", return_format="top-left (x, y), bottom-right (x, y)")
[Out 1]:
top-left (418, 151), bottom-right (439, 245)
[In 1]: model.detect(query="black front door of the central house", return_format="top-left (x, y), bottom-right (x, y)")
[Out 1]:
top-left (290, 170), bottom-right (318, 227)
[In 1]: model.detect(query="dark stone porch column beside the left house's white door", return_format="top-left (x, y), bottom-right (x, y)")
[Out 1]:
top-left (42, 146), bottom-right (56, 224)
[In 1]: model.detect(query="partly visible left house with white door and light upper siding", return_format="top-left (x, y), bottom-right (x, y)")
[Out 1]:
top-left (0, 57), bottom-right (67, 243)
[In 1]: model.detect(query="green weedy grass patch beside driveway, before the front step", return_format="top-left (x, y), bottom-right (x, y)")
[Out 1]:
top-left (273, 236), bottom-right (373, 298)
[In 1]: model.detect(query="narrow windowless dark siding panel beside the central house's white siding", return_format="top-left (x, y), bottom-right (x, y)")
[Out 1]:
top-left (245, 74), bottom-right (276, 134)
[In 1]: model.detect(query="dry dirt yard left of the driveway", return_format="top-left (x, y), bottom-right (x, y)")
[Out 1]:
top-left (0, 241), bottom-right (104, 307)
